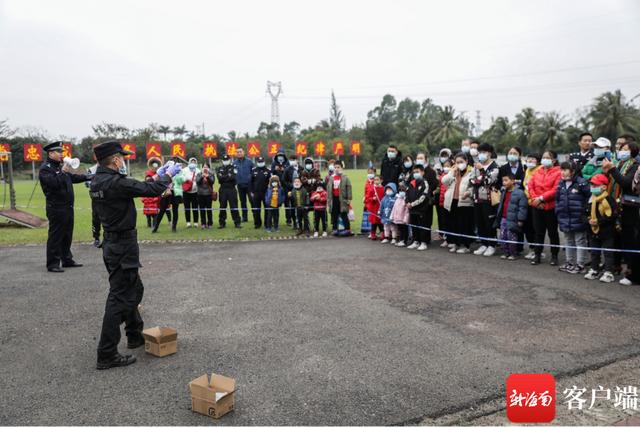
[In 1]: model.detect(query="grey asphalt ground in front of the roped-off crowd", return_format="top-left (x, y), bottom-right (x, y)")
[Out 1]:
top-left (0, 238), bottom-right (640, 425)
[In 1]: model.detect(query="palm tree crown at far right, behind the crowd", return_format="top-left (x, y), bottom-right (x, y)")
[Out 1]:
top-left (589, 89), bottom-right (639, 141)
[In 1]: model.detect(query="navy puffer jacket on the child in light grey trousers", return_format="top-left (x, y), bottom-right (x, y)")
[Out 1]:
top-left (556, 176), bottom-right (591, 233)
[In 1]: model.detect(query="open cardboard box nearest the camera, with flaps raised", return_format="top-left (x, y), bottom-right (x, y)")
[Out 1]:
top-left (189, 374), bottom-right (236, 418)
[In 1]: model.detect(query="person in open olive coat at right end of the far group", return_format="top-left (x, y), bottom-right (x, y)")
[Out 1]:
top-left (327, 160), bottom-right (353, 237)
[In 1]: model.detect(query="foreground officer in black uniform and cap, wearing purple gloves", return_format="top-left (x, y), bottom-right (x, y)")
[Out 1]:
top-left (90, 141), bottom-right (175, 369)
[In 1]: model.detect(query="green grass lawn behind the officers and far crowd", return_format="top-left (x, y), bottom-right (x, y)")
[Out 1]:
top-left (0, 169), bottom-right (367, 245)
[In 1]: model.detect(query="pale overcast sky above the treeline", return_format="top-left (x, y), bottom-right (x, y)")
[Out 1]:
top-left (0, 0), bottom-right (640, 137)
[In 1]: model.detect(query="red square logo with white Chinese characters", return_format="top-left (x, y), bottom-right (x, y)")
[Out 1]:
top-left (507, 374), bottom-right (556, 423)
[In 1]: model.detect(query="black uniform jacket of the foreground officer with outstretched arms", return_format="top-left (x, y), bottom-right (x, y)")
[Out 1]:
top-left (89, 166), bottom-right (171, 233)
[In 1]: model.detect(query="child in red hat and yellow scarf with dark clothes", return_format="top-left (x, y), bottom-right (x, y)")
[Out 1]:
top-left (584, 174), bottom-right (618, 283)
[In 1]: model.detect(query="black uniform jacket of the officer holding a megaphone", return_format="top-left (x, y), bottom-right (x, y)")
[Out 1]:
top-left (39, 159), bottom-right (87, 208)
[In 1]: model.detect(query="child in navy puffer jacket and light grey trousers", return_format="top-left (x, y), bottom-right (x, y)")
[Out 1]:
top-left (556, 162), bottom-right (591, 274)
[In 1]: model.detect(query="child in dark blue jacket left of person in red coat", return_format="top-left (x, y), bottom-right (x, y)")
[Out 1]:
top-left (494, 171), bottom-right (529, 261)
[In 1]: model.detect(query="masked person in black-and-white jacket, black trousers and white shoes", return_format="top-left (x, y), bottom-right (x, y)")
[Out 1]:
top-left (469, 143), bottom-right (502, 257)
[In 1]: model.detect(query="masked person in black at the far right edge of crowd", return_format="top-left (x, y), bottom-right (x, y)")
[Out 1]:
top-left (602, 141), bottom-right (640, 286)
